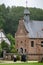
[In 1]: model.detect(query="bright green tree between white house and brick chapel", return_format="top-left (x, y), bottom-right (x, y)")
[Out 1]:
top-left (7, 33), bottom-right (17, 53)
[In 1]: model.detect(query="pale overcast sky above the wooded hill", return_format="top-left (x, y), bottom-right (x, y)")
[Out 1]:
top-left (0, 0), bottom-right (43, 9)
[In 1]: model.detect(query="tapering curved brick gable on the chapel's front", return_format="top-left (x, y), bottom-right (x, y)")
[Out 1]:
top-left (16, 20), bottom-right (27, 35)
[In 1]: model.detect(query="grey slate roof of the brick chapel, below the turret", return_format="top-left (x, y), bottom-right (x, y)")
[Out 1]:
top-left (24, 20), bottom-right (43, 38)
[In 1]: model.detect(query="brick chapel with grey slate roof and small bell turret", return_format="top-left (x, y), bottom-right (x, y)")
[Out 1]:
top-left (15, 8), bottom-right (43, 60)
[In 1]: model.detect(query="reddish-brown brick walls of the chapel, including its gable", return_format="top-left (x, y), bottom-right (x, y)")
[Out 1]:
top-left (15, 20), bottom-right (43, 60)
